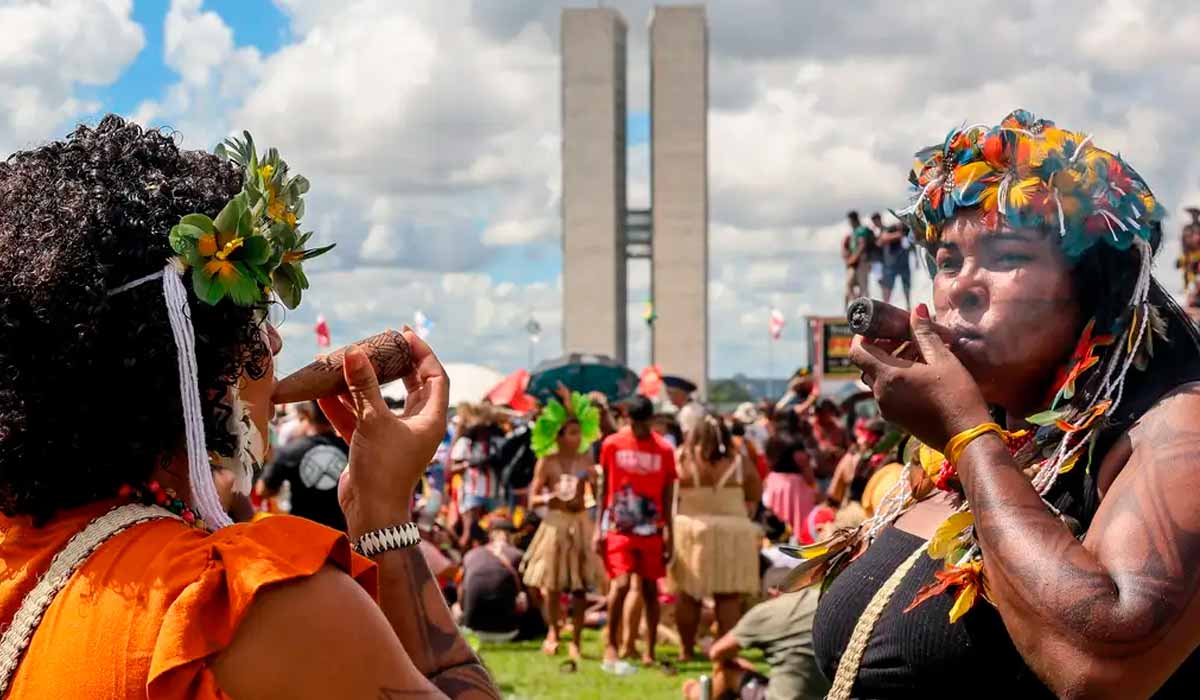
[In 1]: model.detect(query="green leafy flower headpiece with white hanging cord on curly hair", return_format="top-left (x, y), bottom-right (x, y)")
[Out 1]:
top-left (108, 132), bottom-right (334, 527)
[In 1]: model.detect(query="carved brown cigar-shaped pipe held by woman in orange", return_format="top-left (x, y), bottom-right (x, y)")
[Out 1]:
top-left (271, 330), bottom-right (413, 405)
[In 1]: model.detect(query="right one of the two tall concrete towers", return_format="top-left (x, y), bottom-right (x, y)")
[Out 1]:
top-left (650, 5), bottom-right (708, 393)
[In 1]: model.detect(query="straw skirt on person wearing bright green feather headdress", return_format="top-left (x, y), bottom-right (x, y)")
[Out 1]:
top-left (521, 510), bottom-right (604, 592)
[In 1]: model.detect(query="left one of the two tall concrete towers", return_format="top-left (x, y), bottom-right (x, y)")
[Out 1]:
top-left (562, 7), bottom-right (626, 363)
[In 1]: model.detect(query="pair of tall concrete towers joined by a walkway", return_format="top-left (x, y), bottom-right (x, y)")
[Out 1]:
top-left (562, 6), bottom-right (708, 391)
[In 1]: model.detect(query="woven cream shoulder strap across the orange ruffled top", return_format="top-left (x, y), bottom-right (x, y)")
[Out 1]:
top-left (0, 504), bottom-right (179, 698)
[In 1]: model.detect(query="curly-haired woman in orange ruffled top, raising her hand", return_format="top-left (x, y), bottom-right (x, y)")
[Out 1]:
top-left (0, 116), bottom-right (497, 700)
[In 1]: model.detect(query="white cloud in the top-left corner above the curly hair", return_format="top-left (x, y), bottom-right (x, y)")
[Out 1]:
top-left (0, 0), bottom-right (145, 154)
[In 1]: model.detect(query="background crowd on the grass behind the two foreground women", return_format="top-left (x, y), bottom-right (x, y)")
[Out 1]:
top-left (256, 370), bottom-right (899, 698)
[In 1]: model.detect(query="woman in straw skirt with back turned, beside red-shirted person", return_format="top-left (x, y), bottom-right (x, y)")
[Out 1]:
top-left (668, 414), bottom-right (762, 662)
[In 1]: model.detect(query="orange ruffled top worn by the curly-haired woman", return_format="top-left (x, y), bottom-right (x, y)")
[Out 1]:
top-left (0, 502), bottom-right (377, 700)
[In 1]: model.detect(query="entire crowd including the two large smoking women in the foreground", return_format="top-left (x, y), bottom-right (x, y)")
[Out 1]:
top-left (7, 110), bottom-right (1200, 700)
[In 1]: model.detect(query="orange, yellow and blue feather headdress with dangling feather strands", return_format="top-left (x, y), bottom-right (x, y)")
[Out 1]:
top-left (791, 109), bottom-right (1165, 622)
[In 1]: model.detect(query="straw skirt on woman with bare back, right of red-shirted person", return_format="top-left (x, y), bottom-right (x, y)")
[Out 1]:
top-left (668, 486), bottom-right (762, 598)
